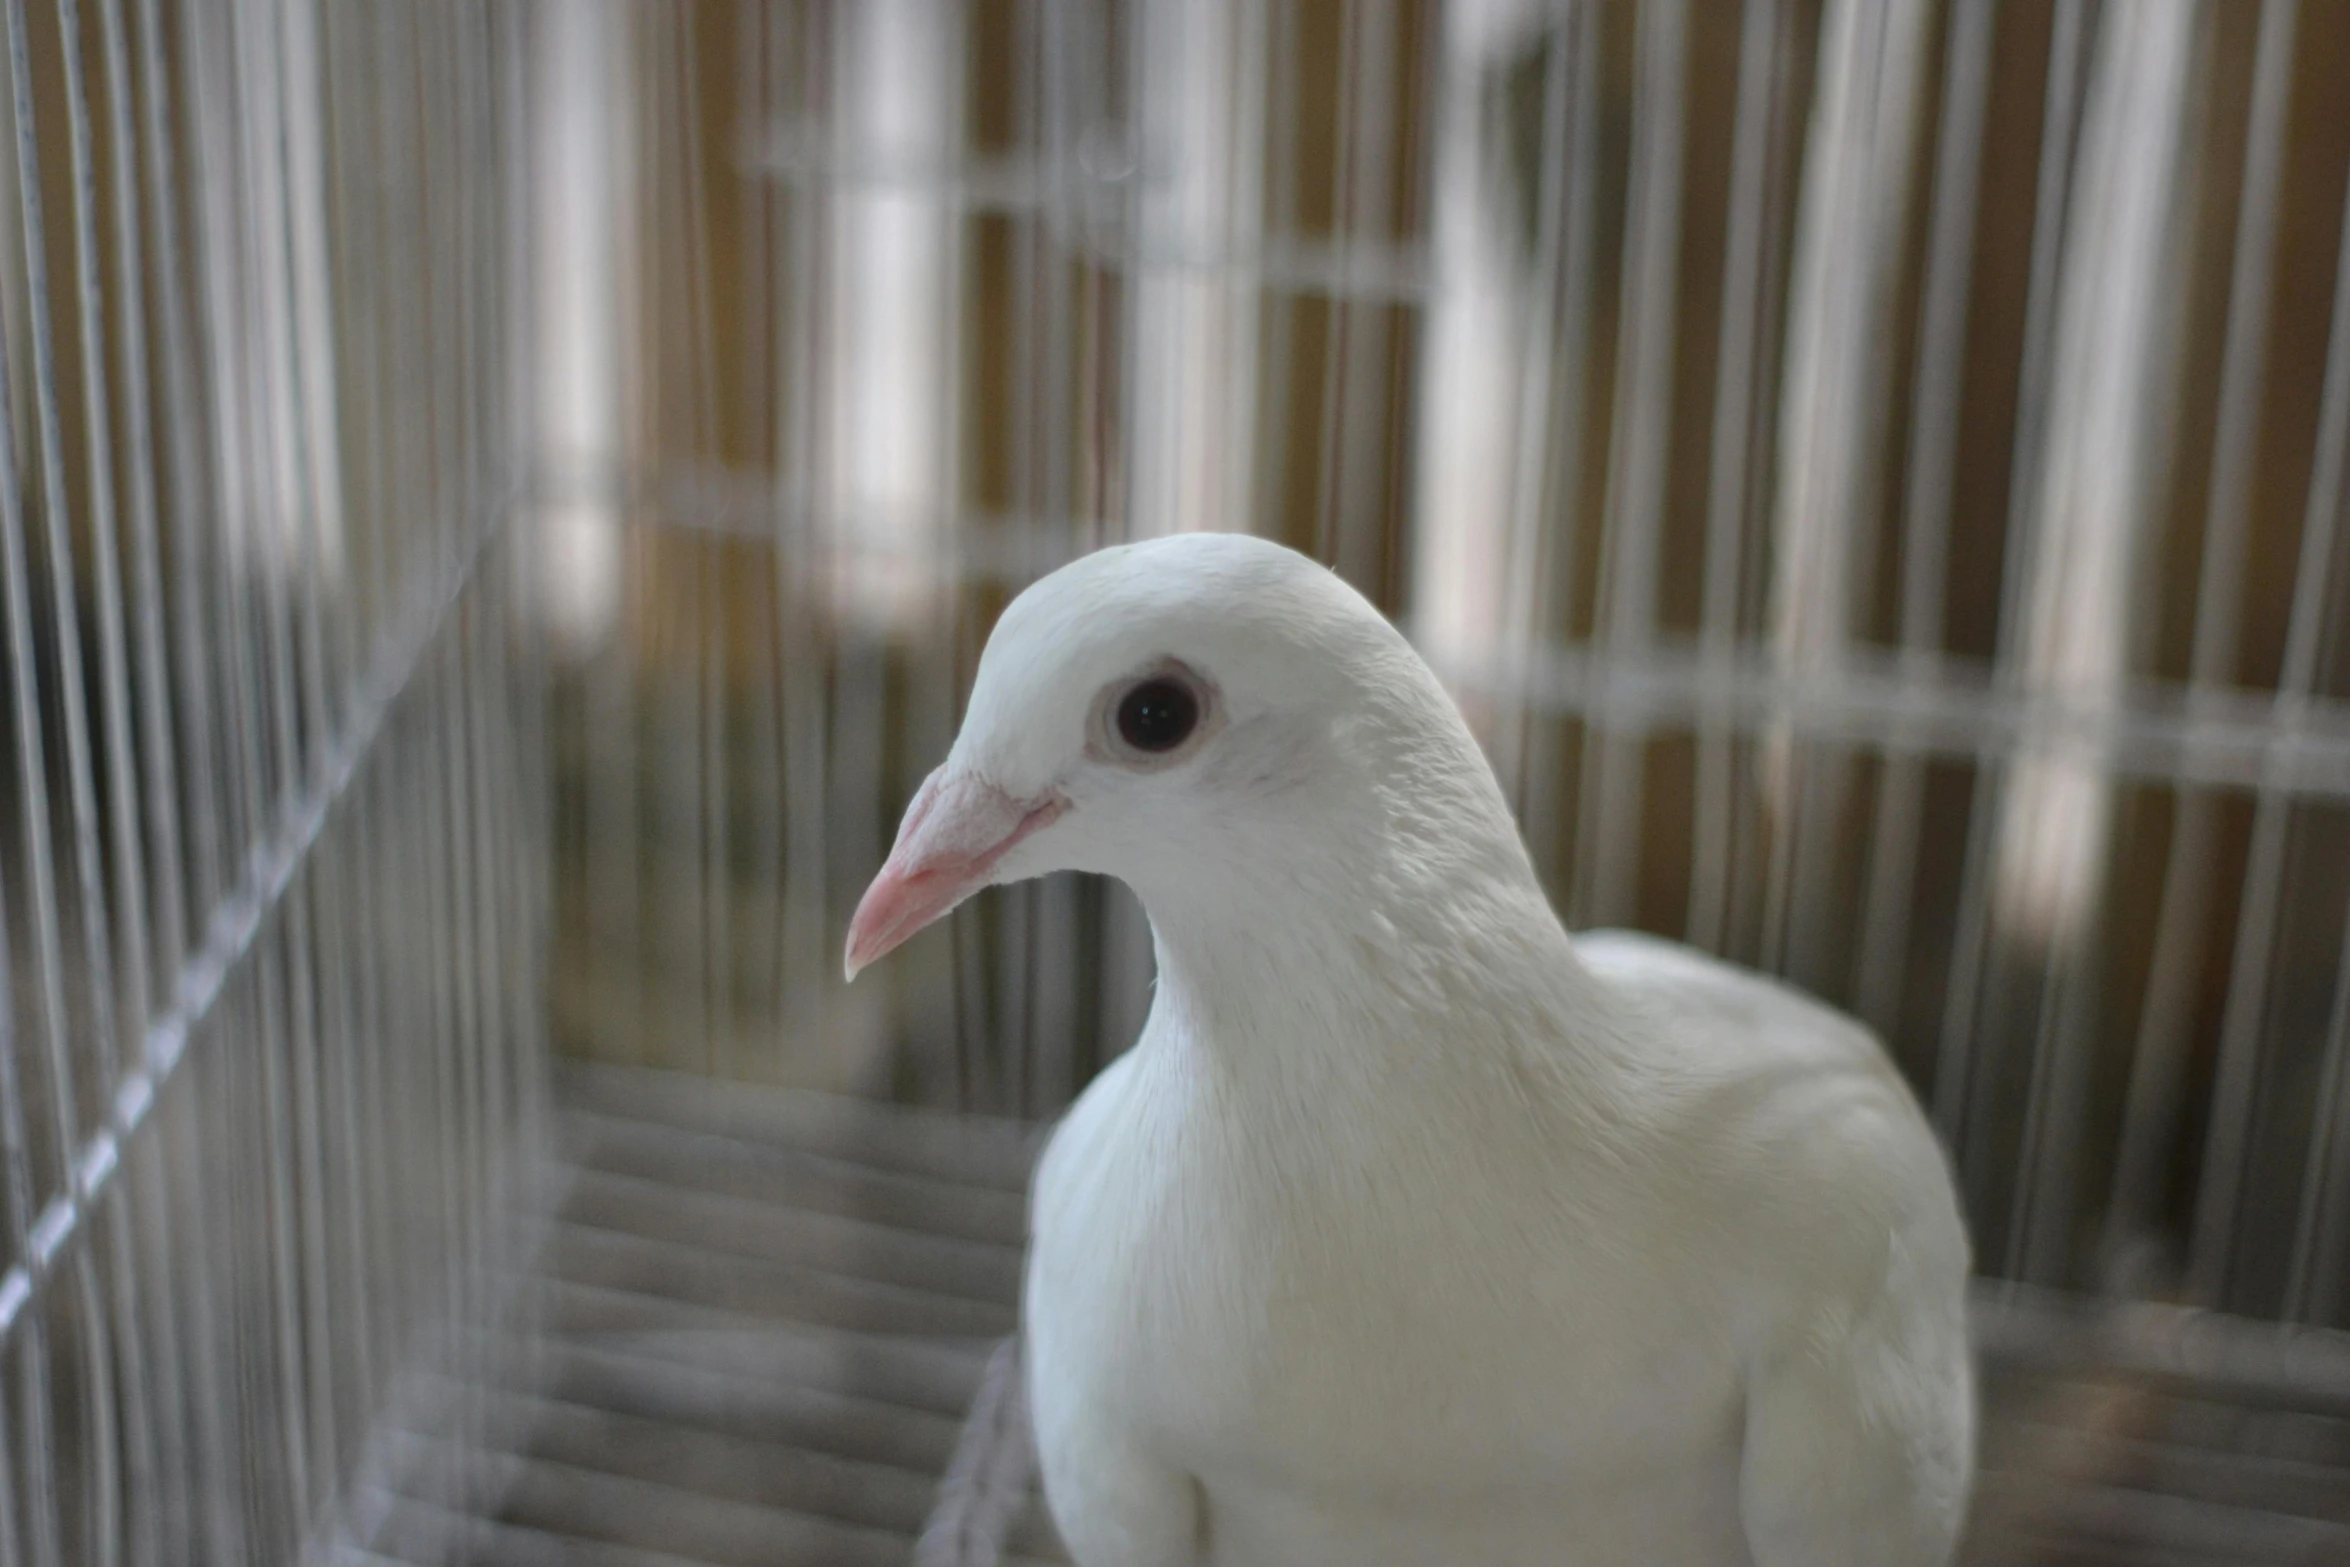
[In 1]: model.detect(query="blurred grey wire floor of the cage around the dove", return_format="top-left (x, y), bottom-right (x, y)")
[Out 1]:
top-left (345, 1067), bottom-right (2350, 1567)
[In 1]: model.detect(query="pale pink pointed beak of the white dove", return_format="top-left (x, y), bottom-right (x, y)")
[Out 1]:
top-left (844, 768), bottom-right (1069, 980)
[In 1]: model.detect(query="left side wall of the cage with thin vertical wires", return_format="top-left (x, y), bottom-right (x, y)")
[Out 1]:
top-left (0, 0), bottom-right (548, 1565)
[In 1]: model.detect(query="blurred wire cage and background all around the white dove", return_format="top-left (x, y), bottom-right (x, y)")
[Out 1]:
top-left (0, 0), bottom-right (2350, 1567)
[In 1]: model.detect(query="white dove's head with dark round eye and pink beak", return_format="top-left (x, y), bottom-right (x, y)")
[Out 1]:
top-left (846, 533), bottom-right (1485, 977)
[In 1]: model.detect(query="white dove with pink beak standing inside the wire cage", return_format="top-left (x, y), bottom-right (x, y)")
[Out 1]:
top-left (848, 533), bottom-right (1976, 1567)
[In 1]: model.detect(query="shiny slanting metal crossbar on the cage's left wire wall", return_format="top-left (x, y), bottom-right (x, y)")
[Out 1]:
top-left (0, 496), bottom-right (515, 1346)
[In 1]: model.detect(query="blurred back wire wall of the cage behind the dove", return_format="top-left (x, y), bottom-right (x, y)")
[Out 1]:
top-left (509, 0), bottom-right (2350, 1313)
